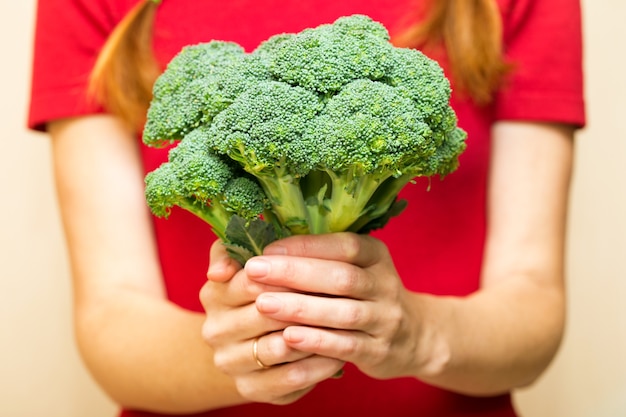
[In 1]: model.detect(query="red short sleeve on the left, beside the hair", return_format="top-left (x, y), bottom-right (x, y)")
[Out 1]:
top-left (27, 0), bottom-right (136, 131)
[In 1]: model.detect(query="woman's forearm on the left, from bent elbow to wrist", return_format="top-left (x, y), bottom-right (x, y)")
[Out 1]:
top-left (75, 291), bottom-right (243, 413)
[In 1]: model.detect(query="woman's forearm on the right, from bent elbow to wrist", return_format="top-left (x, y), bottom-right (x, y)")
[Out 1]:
top-left (412, 278), bottom-right (565, 396)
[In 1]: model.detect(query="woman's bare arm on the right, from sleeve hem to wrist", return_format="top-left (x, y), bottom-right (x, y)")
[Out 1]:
top-left (410, 119), bottom-right (573, 394)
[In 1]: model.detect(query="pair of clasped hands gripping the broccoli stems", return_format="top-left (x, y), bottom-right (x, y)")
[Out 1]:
top-left (200, 233), bottom-right (419, 404)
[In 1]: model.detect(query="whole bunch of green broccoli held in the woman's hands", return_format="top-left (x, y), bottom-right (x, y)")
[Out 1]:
top-left (143, 15), bottom-right (466, 262)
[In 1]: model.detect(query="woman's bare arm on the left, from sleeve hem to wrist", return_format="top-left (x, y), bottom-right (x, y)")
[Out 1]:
top-left (50, 116), bottom-right (243, 413)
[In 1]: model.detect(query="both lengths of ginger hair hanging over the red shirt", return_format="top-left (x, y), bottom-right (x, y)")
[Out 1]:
top-left (90, 0), bottom-right (509, 129)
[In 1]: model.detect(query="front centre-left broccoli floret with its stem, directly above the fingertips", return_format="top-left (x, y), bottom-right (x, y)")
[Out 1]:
top-left (208, 81), bottom-right (321, 233)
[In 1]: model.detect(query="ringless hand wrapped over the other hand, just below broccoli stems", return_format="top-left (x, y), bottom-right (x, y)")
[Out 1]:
top-left (245, 233), bottom-right (420, 379)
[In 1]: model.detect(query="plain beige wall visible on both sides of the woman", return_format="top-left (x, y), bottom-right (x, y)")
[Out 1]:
top-left (0, 0), bottom-right (626, 417)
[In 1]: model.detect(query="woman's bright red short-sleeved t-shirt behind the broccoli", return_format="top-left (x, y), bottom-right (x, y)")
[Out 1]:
top-left (28, 0), bottom-right (585, 417)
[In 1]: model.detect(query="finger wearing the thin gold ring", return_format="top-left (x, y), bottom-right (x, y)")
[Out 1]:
top-left (213, 331), bottom-right (311, 375)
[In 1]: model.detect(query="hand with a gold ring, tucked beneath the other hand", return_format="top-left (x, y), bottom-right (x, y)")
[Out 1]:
top-left (200, 243), bottom-right (343, 404)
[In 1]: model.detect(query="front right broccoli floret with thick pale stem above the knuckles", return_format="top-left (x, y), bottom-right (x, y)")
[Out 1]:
top-left (305, 80), bottom-right (436, 233)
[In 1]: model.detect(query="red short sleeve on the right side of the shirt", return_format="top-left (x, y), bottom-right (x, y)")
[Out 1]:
top-left (495, 0), bottom-right (586, 127)
